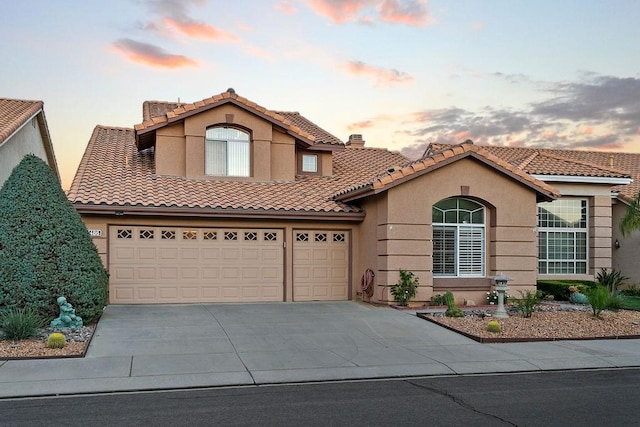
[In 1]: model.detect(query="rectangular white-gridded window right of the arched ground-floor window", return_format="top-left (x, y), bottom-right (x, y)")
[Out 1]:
top-left (538, 199), bottom-right (588, 274)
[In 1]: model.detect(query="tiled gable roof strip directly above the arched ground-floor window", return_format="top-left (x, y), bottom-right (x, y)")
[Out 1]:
top-left (336, 141), bottom-right (559, 202)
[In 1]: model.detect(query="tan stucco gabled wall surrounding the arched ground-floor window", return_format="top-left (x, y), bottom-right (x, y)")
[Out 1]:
top-left (354, 159), bottom-right (537, 304)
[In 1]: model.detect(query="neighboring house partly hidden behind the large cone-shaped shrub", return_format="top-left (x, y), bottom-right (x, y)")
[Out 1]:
top-left (0, 98), bottom-right (60, 188)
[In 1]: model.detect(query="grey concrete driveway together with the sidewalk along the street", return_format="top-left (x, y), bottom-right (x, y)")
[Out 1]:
top-left (0, 302), bottom-right (640, 398)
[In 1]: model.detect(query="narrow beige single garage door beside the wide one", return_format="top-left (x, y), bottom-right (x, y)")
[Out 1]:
top-left (293, 230), bottom-right (349, 301)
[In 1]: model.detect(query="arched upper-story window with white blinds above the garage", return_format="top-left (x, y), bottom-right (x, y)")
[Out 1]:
top-left (204, 127), bottom-right (251, 177)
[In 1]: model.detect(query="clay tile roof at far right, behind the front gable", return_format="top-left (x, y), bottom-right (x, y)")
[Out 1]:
top-left (427, 144), bottom-right (640, 201)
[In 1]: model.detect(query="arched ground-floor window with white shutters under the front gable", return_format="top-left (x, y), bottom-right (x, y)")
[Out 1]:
top-left (432, 198), bottom-right (485, 277)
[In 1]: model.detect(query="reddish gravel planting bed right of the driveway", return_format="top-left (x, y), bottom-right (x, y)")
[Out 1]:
top-left (418, 307), bottom-right (640, 343)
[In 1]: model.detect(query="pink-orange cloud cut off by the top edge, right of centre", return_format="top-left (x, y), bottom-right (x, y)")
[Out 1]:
top-left (307, 0), bottom-right (435, 26)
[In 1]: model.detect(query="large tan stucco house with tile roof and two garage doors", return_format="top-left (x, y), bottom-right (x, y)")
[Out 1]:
top-left (68, 89), bottom-right (630, 304)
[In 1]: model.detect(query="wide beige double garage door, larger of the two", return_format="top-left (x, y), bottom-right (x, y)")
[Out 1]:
top-left (109, 226), bottom-right (284, 304)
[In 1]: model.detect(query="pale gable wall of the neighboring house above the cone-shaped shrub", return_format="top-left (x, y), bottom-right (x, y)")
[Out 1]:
top-left (0, 114), bottom-right (51, 187)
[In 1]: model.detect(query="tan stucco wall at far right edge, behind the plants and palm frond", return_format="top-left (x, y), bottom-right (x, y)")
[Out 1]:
top-left (611, 200), bottom-right (640, 285)
